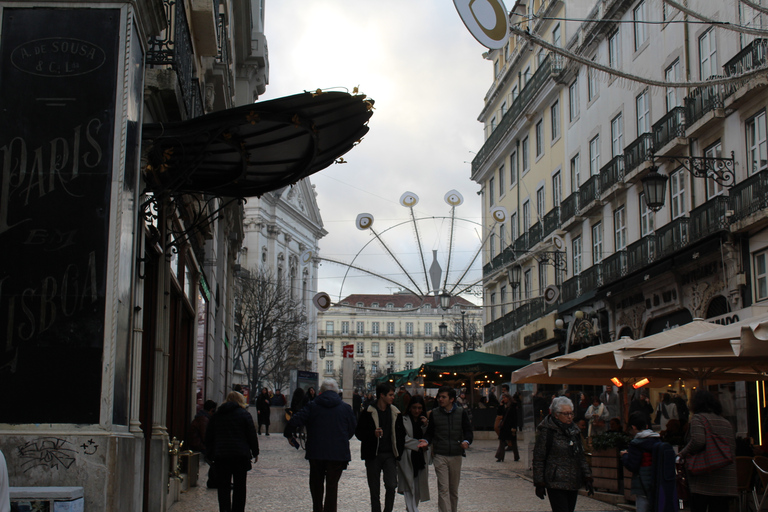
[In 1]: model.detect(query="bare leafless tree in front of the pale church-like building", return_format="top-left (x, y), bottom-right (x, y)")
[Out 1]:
top-left (233, 268), bottom-right (307, 394)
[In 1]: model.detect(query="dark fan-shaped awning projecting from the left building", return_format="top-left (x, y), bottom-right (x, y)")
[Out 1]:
top-left (143, 92), bottom-right (373, 197)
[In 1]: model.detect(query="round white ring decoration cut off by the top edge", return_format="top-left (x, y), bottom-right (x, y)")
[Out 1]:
top-left (453, 0), bottom-right (509, 50)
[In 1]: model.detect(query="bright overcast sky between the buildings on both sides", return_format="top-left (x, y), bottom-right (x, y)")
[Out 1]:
top-left (260, 0), bottom-right (492, 301)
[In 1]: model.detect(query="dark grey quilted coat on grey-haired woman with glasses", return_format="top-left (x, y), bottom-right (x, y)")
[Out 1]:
top-left (533, 415), bottom-right (592, 491)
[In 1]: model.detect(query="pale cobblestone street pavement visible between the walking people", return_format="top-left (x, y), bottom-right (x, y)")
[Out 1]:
top-left (170, 434), bottom-right (620, 512)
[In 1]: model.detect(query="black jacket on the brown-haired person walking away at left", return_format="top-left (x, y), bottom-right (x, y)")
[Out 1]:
top-left (205, 402), bottom-right (259, 466)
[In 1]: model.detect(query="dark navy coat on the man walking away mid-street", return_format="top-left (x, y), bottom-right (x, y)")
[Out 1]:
top-left (285, 391), bottom-right (357, 461)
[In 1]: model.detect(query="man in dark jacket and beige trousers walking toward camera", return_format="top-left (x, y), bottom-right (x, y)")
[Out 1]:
top-left (424, 386), bottom-right (474, 512)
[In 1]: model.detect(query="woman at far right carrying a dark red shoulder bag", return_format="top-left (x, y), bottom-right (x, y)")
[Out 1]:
top-left (679, 389), bottom-right (738, 512)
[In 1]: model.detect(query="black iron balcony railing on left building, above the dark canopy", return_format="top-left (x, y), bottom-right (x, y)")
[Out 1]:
top-left (146, 0), bottom-right (205, 119)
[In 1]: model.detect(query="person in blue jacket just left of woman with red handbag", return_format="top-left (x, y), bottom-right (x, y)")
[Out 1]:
top-left (621, 411), bottom-right (661, 512)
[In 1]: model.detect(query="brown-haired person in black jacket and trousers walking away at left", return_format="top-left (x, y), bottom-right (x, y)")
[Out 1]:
top-left (205, 391), bottom-right (259, 512)
